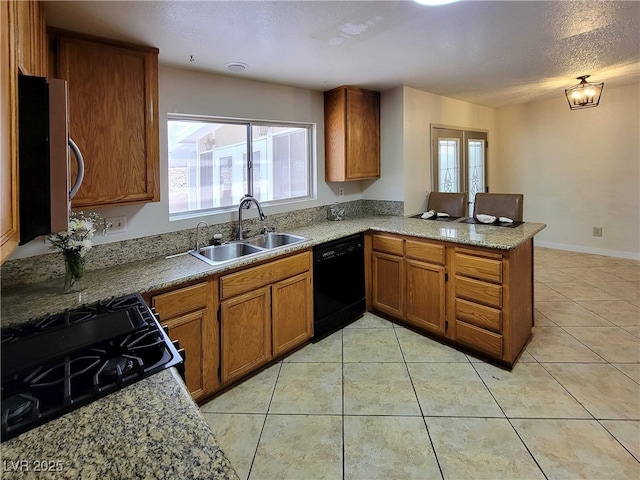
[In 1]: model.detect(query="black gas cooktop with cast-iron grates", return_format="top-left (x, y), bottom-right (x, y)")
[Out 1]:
top-left (0, 294), bottom-right (184, 442)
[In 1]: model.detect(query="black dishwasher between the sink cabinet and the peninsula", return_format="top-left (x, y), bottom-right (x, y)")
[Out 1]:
top-left (313, 234), bottom-right (366, 340)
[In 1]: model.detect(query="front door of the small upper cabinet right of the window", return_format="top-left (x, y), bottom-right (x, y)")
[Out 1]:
top-left (347, 89), bottom-right (380, 180)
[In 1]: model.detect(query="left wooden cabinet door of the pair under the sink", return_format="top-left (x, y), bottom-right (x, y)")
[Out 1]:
top-left (220, 287), bottom-right (271, 384)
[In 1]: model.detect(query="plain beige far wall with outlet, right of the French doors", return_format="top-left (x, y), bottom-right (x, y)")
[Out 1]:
top-left (490, 82), bottom-right (640, 258)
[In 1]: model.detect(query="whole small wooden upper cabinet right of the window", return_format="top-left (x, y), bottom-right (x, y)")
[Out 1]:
top-left (324, 86), bottom-right (380, 182)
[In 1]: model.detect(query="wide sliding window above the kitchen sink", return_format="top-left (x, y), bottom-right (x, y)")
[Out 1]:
top-left (167, 115), bottom-right (312, 216)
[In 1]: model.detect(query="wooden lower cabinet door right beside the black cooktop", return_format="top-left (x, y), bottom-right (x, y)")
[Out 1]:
top-left (163, 310), bottom-right (208, 400)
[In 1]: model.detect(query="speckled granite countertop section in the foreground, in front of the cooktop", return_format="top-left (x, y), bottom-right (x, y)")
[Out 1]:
top-left (1, 368), bottom-right (238, 480)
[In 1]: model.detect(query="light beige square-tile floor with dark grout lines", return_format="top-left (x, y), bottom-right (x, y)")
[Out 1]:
top-left (201, 248), bottom-right (640, 480)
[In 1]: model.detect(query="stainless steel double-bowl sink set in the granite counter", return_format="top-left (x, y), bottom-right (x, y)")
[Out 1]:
top-left (189, 232), bottom-right (308, 265)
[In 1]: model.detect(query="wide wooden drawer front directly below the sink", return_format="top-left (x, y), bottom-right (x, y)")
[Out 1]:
top-left (220, 251), bottom-right (311, 300)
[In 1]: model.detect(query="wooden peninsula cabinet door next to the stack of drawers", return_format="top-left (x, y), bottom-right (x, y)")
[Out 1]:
top-left (406, 260), bottom-right (445, 335)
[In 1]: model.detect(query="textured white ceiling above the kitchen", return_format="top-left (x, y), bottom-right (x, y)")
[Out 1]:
top-left (45, 0), bottom-right (640, 107)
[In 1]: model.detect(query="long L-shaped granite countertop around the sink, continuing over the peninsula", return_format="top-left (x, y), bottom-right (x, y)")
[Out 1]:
top-left (0, 216), bottom-right (546, 326)
